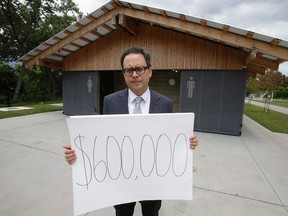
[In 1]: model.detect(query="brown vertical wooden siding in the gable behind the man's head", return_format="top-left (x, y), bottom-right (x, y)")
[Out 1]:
top-left (63, 23), bottom-right (245, 71)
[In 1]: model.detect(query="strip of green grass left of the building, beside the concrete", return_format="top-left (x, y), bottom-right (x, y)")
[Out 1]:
top-left (0, 101), bottom-right (63, 119)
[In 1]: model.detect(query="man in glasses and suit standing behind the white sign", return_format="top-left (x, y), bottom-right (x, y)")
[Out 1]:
top-left (64, 47), bottom-right (198, 216)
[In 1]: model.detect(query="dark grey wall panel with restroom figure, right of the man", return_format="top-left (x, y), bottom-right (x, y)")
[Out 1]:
top-left (180, 70), bottom-right (247, 135)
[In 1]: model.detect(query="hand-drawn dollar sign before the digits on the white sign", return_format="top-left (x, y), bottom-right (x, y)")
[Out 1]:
top-left (74, 135), bottom-right (92, 190)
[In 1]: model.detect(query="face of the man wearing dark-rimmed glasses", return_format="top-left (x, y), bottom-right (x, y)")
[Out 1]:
top-left (123, 53), bottom-right (152, 96)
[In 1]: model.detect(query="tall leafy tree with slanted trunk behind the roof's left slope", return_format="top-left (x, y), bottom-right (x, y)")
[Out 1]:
top-left (0, 0), bottom-right (83, 100)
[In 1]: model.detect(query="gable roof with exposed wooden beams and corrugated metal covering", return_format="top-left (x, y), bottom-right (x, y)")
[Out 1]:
top-left (17, 0), bottom-right (288, 74)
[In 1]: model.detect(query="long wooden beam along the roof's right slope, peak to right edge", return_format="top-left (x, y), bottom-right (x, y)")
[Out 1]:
top-left (119, 8), bottom-right (288, 61)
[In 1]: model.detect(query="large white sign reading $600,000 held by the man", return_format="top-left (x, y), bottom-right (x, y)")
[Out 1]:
top-left (67, 113), bottom-right (194, 215)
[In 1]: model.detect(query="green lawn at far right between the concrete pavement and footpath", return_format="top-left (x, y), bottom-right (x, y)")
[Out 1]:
top-left (244, 103), bottom-right (288, 134)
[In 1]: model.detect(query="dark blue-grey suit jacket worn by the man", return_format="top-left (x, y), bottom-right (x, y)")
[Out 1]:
top-left (103, 89), bottom-right (173, 114)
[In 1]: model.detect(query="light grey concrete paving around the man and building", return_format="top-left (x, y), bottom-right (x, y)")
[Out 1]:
top-left (0, 112), bottom-right (288, 216)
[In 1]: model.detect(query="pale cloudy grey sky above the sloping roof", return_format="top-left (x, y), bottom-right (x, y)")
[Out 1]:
top-left (73, 0), bottom-right (288, 75)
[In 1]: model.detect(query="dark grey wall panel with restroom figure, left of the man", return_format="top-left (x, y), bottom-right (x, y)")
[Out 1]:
top-left (62, 72), bottom-right (98, 115)
